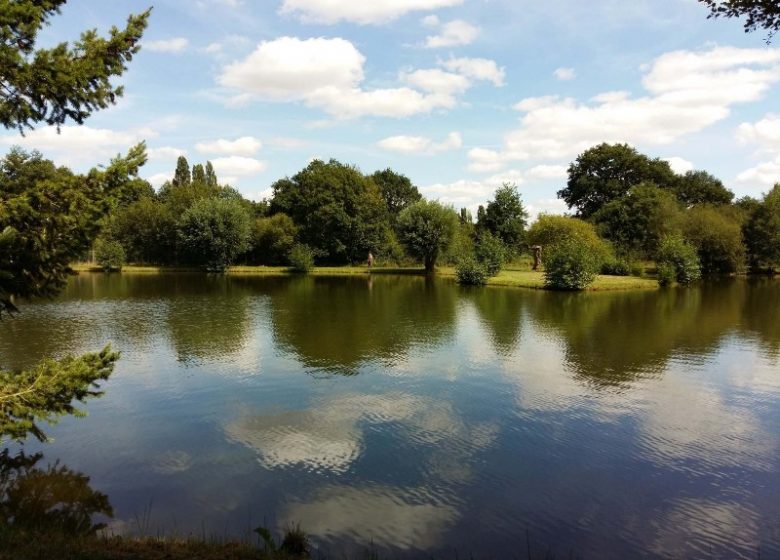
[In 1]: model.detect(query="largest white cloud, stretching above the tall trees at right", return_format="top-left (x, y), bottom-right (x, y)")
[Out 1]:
top-left (469, 47), bottom-right (780, 171)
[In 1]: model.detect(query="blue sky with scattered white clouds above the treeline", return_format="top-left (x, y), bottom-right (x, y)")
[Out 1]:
top-left (0, 0), bottom-right (780, 216)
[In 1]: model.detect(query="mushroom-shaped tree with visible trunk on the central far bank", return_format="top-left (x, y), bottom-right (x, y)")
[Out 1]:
top-left (398, 200), bottom-right (458, 273)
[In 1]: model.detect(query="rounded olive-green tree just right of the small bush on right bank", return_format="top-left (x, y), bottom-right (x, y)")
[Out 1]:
top-left (682, 205), bottom-right (745, 274)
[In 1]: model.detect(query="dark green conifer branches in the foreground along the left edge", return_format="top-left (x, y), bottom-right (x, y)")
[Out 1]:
top-left (0, 0), bottom-right (149, 439)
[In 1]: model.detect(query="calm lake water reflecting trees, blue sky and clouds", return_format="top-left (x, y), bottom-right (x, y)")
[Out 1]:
top-left (0, 274), bottom-right (780, 558)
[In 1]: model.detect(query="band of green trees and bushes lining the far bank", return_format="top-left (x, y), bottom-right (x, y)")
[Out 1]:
top-left (42, 140), bottom-right (780, 290)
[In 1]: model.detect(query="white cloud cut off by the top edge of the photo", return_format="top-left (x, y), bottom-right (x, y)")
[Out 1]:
top-left (279, 0), bottom-right (463, 25)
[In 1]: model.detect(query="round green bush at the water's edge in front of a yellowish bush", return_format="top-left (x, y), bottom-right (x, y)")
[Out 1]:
top-left (544, 239), bottom-right (602, 290)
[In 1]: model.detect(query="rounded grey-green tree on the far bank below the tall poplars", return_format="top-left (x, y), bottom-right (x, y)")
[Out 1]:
top-left (178, 198), bottom-right (250, 270)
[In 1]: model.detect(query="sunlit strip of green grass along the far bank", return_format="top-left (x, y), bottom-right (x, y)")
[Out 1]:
top-left (73, 263), bottom-right (658, 291)
